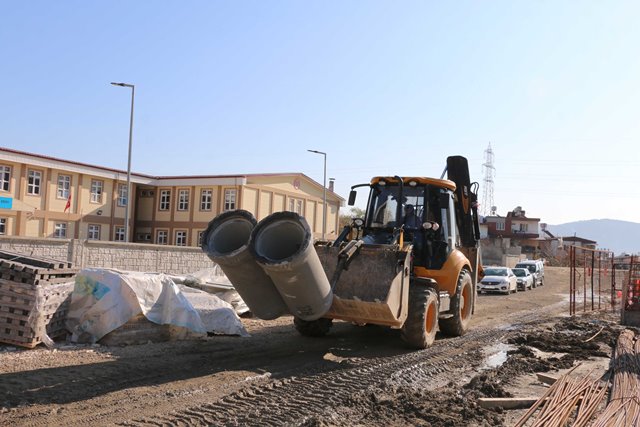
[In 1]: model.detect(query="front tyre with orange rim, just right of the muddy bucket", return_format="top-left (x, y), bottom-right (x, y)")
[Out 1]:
top-left (402, 284), bottom-right (438, 349)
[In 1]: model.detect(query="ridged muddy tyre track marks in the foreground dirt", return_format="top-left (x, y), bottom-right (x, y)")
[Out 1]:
top-left (123, 330), bottom-right (505, 426)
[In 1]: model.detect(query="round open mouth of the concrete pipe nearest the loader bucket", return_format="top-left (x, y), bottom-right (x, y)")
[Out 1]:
top-left (255, 220), bottom-right (308, 262)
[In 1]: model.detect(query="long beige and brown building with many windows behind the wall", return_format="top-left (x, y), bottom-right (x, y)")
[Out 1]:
top-left (0, 148), bottom-right (344, 246)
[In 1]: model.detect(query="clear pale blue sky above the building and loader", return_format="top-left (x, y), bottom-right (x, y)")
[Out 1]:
top-left (0, 1), bottom-right (640, 224)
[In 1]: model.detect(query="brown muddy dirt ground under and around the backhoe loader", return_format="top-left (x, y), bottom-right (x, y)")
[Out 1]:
top-left (0, 267), bottom-right (621, 426)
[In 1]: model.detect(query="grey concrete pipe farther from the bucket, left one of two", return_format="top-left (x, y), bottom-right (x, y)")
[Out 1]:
top-left (201, 210), bottom-right (289, 320)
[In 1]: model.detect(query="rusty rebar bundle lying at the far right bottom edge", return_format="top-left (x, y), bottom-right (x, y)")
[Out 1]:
top-left (592, 329), bottom-right (640, 427)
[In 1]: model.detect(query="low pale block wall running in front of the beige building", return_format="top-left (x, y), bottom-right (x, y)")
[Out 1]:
top-left (0, 237), bottom-right (215, 274)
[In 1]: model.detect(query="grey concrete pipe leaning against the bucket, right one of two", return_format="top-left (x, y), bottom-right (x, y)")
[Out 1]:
top-left (249, 212), bottom-right (333, 320)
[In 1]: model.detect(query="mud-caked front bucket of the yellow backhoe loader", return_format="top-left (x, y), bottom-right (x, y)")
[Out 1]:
top-left (316, 245), bottom-right (411, 328)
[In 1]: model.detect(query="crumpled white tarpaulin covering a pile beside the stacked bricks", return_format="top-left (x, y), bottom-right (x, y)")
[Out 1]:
top-left (67, 268), bottom-right (247, 342)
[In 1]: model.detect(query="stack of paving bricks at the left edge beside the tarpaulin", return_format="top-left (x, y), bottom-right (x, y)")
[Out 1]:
top-left (0, 251), bottom-right (78, 348)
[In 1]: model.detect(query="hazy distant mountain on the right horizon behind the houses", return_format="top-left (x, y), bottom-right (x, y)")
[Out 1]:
top-left (547, 219), bottom-right (640, 255)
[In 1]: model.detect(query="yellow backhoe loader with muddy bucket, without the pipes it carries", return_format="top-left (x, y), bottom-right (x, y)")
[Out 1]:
top-left (294, 156), bottom-right (481, 348)
